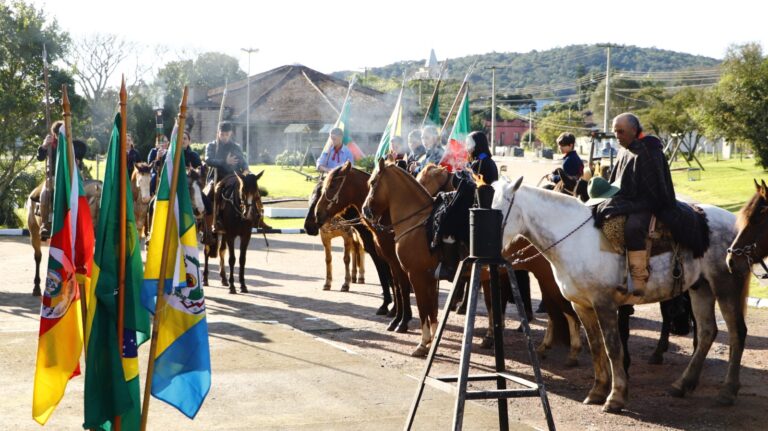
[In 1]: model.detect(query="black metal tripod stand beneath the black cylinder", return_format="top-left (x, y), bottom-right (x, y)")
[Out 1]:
top-left (405, 255), bottom-right (555, 430)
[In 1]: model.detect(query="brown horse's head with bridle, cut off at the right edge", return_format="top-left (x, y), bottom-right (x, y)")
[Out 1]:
top-left (726, 180), bottom-right (768, 272)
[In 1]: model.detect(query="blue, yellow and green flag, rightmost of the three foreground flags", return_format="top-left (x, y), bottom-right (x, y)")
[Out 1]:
top-left (141, 122), bottom-right (211, 418)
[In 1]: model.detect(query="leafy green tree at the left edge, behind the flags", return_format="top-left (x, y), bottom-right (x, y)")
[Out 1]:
top-left (0, 1), bottom-right (74, 225)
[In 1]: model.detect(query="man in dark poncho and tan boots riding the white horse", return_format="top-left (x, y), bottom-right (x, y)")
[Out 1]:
top-left (595, 113), bottom-right (677, 296)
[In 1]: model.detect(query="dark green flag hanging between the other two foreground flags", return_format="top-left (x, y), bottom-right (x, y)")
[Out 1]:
top-left (83, 114), bottom-right (149, 431)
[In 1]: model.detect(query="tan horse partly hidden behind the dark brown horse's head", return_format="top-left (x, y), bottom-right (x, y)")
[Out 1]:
top-left (304, 183), bottom-right (364, 294)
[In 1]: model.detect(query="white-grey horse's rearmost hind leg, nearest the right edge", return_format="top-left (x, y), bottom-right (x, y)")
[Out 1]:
top-left (715, 273), bottom-right (749, 406)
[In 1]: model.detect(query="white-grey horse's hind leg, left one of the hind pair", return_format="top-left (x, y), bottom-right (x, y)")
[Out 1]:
top-left (669, 281), bottom-right (717, 397)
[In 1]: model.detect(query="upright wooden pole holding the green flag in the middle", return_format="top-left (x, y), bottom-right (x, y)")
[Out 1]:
top-left (112, 75), bottom-right (128, 431)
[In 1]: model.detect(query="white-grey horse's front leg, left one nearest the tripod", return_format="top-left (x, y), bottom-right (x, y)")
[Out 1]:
top-left (573, 303), bottom-right (611, 404)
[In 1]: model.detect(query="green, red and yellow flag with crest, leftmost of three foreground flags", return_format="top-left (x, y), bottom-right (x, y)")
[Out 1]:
top-left (32, 126), bottom-right (94, 425)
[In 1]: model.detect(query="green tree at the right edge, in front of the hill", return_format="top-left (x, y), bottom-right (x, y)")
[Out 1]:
top-left (698, 43), bottom-right (768, 169)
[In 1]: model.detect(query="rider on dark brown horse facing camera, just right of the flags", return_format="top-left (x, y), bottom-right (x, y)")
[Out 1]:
top-left (205, 122), bottom-right (248, 236)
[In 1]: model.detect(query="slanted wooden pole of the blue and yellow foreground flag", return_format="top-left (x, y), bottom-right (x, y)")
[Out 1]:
top-left (141, 85), bottom-right (187, 431)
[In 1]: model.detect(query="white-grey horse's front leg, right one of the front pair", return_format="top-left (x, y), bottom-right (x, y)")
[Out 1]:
top-left (595, 303), bottom-right (628, 413)
